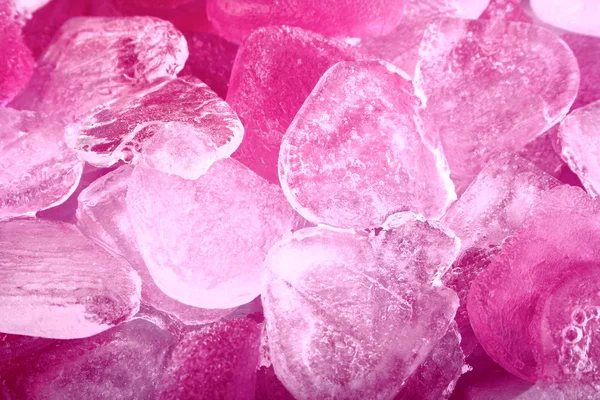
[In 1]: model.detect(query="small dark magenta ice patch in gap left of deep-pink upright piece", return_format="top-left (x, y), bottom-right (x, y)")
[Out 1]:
top-left (182, 33), bottom-right (238, 99)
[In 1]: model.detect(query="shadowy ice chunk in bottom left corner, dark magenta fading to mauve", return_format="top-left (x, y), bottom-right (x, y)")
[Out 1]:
top-left (0, 319), bottom-right (177, 400)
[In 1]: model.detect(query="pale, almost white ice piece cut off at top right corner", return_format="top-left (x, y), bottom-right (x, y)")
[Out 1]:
top-left (530, 0), bottom-right (600, 36)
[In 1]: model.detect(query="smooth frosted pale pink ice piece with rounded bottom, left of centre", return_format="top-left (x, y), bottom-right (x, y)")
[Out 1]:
top-left (127, 159), bottom-right (294, 308)
